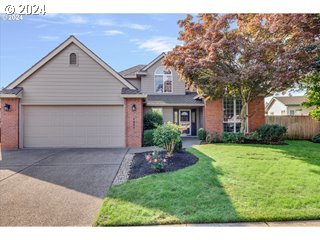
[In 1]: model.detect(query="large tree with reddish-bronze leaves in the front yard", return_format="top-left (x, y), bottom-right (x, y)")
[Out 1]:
top-left (164, 14), bottom-right (320, 132)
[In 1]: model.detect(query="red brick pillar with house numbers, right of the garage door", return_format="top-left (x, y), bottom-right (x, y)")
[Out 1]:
top-left (124, 98), bottom-right (143, 147)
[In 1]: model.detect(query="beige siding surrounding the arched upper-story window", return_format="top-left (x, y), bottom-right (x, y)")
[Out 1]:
top-left (141, 60), bottom-right (185, 95)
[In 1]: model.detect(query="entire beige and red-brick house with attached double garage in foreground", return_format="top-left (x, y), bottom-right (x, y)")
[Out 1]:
top-left (0, 36), bottom-right (264, 149)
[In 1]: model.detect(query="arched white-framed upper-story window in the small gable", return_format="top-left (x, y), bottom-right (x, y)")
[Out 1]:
top-left (154, 67), bottom-right (172, 93)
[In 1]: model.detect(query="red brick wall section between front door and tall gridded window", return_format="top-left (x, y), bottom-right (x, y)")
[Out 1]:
top-left (203, 99), bottom-right (223, 133)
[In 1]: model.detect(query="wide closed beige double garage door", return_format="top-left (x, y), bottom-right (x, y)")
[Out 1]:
top-left (23, 106), bottom-right (125, 148)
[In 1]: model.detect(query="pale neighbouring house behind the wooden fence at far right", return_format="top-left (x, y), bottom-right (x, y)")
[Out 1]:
top-left (266, 96), bottom-right (311, 116)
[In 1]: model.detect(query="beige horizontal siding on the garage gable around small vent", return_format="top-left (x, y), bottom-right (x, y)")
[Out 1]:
top-left (19, 44), bottom-right (124, 105)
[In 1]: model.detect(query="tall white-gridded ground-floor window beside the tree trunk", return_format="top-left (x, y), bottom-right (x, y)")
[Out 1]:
top-left (223, 98), bottom-right (242, 132)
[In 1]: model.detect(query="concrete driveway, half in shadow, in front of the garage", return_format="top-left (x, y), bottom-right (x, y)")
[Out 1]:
top-left (0, 149), bottom-right (127, 226)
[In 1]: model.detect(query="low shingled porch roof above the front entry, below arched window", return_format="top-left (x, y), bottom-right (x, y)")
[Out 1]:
top-left (146, 92), bottom-right (204, 106)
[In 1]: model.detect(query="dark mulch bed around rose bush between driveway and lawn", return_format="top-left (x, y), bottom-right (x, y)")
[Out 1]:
top-left (129, 151), bottom-right (198, 179)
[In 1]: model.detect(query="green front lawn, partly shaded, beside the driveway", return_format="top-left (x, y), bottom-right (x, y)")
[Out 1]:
top-left (95, 141), bottom-right (320, 226)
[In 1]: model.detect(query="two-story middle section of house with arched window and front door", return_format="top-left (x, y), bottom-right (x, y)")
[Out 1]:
top-left (120, 53), bottom-right (204, 136)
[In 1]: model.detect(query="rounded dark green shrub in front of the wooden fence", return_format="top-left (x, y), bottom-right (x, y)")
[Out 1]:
top-left (257, 124), bottom-right (287, 143)
